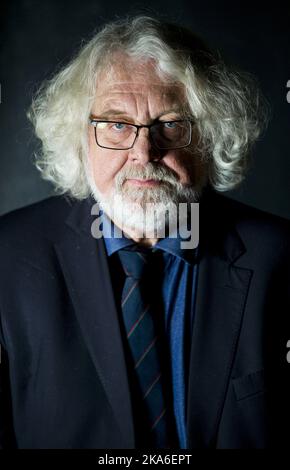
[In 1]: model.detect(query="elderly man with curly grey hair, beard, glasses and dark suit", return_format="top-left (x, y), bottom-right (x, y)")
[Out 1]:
top-left (0, 17), bottom-right (290, 449)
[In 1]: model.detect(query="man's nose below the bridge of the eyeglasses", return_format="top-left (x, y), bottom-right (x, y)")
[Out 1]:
top-left (129, 127), bottom-right (160, 164)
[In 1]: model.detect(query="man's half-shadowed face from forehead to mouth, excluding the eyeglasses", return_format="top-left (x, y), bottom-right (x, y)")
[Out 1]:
top-left (89, 57), bottom-right (206, 237)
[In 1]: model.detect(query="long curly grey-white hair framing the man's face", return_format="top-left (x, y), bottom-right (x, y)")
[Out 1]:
top-left (28, 16), bottom-right (267, 199)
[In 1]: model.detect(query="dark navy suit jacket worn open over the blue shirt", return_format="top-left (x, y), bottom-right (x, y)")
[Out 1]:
top-left (0, 194), bottom-right (290, 448)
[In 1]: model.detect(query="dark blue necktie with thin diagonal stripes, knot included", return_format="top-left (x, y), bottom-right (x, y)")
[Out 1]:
top-left (118, 249), bottom-right (174, 448)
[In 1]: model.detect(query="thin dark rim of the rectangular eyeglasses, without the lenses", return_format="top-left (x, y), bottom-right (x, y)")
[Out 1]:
top-left (89, 117), bottom-right (194, 150)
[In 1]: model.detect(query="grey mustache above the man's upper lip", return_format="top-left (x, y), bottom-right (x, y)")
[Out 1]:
top-left (115, 162), bottom-right (179, 188)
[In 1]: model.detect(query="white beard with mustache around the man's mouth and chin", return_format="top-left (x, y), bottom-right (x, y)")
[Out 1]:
top-left (90, 163), bottom-right (203, 238)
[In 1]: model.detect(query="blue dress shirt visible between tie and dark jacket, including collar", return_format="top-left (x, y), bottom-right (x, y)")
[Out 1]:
top-left (100, 212), bottom-right (198, 449)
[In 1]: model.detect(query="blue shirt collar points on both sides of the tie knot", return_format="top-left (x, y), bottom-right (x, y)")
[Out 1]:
top-left (100, 211), bottom-right (197, 264)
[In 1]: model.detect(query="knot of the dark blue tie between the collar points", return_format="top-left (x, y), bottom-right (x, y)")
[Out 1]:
top-left (118, 249), bottom-right (159, 279)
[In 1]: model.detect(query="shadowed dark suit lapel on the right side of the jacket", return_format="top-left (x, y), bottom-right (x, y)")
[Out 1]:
top-left (187, 195), bottom-right (252, 448)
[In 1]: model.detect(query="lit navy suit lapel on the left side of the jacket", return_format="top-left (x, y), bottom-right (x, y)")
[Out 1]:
top-left (55, 200), bottom-right (134, 448)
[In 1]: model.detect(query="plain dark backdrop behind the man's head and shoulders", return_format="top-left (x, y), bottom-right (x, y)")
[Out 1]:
top-left (0, 0), bottom-right (290, 218)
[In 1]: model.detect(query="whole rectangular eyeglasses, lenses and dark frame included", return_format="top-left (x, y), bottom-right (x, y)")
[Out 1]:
top-left (90, 117), bottom-right (193, 150)
